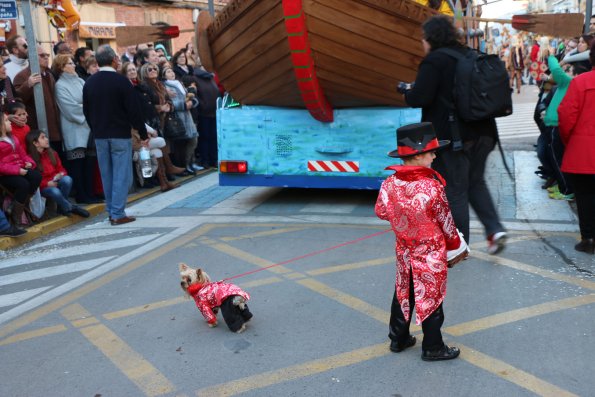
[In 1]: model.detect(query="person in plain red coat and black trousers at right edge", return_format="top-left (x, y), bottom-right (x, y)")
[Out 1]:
top-left (558, 40), bottom-right (595, 254)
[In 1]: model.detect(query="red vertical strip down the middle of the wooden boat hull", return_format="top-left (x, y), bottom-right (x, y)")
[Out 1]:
top-left (283, 0), bottom-right (333, 122)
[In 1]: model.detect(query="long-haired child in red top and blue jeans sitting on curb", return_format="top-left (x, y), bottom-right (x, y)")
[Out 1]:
top-left (26, 130), bottom-right (89, 218)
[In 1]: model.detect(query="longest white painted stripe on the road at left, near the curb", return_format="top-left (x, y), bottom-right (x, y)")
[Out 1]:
top-left (0, 233), bottom-right (161, 269)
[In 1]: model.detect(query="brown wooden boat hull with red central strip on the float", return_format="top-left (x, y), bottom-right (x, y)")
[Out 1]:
top-left (198, 0), bottom-right (450, 121)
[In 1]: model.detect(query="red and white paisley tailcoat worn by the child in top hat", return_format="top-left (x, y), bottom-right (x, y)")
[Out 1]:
top-left (375, 165), bottom-right (461, 325)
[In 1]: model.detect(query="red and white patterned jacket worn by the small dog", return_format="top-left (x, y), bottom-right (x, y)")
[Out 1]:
top-left (188, 281), bottom-right (250, 324)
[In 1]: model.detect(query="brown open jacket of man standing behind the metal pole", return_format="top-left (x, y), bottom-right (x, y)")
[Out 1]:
top-left (14, 68), bottom-right (62, 142)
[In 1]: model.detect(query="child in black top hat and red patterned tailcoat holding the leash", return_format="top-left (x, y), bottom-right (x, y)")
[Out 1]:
top-left (375, 122), bottom-right (468, 361)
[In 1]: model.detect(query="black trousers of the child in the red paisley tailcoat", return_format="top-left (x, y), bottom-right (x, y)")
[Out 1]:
top-left (388, 277), bottom-right (444, 351)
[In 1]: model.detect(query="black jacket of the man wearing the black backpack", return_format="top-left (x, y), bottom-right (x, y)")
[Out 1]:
top-left (405, 47), bottom-right (498, 141)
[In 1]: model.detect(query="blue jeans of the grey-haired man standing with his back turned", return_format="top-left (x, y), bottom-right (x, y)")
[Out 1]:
top-left (95, 138), bottom-right (132, 219)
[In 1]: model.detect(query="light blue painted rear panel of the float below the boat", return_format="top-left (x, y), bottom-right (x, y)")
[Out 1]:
top-left (217, 106), bottom-right (421, 189)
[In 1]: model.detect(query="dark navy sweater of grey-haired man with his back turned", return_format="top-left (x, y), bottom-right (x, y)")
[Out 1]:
top-left (83, 70), bottom-right (147, 140)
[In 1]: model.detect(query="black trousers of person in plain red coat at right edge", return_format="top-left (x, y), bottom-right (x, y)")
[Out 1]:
top-left (567, 174), bottom-right (595, 239)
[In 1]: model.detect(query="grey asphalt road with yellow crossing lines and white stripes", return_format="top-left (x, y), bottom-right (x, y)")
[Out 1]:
top-left (0, 87), bottom-right (595, 397)
